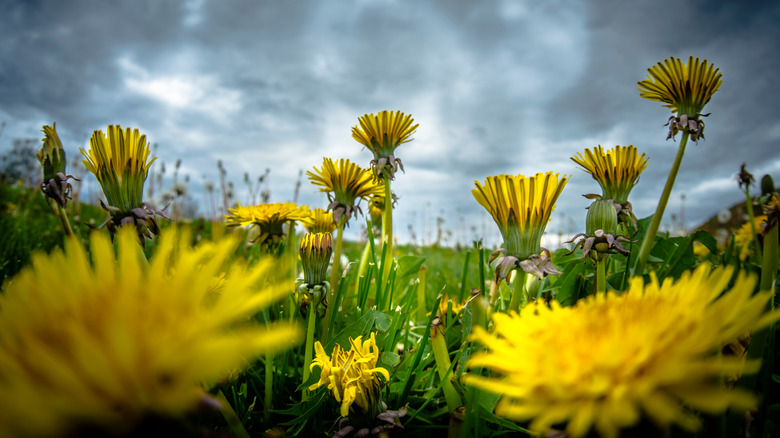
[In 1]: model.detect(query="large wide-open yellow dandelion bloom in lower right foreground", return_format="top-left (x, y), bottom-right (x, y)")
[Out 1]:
top-left (466, 264), bottom-right (780, 437)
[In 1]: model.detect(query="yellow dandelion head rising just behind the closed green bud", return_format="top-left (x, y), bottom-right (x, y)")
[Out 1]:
top-left (571, 145), bottom-right (648, 228)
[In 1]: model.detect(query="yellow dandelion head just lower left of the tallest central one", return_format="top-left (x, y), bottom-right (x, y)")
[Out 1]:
top-left (306, 158), bottom-right (384, 222)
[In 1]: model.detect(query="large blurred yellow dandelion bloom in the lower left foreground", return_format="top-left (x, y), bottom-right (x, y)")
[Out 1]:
top-left (0, 228), bottom-right (300, 437)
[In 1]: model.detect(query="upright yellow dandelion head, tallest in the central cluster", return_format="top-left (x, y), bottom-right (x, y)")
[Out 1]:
top-left (352, 111), bottom-right (420, 179)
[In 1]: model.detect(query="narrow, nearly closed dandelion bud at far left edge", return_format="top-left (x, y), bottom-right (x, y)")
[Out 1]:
top-left (38, 123), bottom-right (78, 208)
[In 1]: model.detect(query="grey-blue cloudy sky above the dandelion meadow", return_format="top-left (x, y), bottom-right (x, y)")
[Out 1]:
top-left (0, 0), bottom-right (780, 246)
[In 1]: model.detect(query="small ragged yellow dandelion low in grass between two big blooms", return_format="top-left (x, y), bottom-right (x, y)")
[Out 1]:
top-left (309, 332), bottom-right (390, 418)
